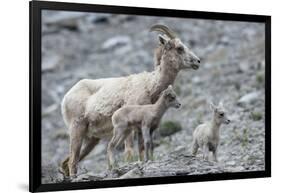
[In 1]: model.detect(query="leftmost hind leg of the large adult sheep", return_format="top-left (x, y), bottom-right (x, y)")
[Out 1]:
top-left (68, 118), bottom-right (87, 177)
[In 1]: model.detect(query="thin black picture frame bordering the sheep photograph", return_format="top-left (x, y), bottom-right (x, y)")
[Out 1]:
top-left (29, 1), bottom-right (271, 192)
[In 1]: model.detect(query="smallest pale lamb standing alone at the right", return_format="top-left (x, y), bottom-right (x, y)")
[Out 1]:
top-left (192, 103), bottom-right (230, 161)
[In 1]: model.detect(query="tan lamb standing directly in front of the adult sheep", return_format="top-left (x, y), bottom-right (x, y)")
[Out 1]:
top-left (107, 85), bottom-right (181, 169)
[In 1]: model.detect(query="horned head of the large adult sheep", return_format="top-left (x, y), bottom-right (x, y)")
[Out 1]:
top-left (150, 24), bottom-right (200, 71)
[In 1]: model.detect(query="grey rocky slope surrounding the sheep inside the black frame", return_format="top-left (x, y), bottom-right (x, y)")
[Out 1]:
top-left (42, 11), bottom-right (265, 183)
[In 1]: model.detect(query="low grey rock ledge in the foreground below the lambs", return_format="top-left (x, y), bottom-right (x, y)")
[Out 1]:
top-left (55, 150), bottom-right (248, 182)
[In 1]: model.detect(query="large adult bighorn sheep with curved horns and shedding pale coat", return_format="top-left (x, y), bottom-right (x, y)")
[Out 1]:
top-left (61, 24), bottom-right (200, 177)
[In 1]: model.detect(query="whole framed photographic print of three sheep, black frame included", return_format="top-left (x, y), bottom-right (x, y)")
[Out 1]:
top-left (29, 1), bottom-right (271, 192)
